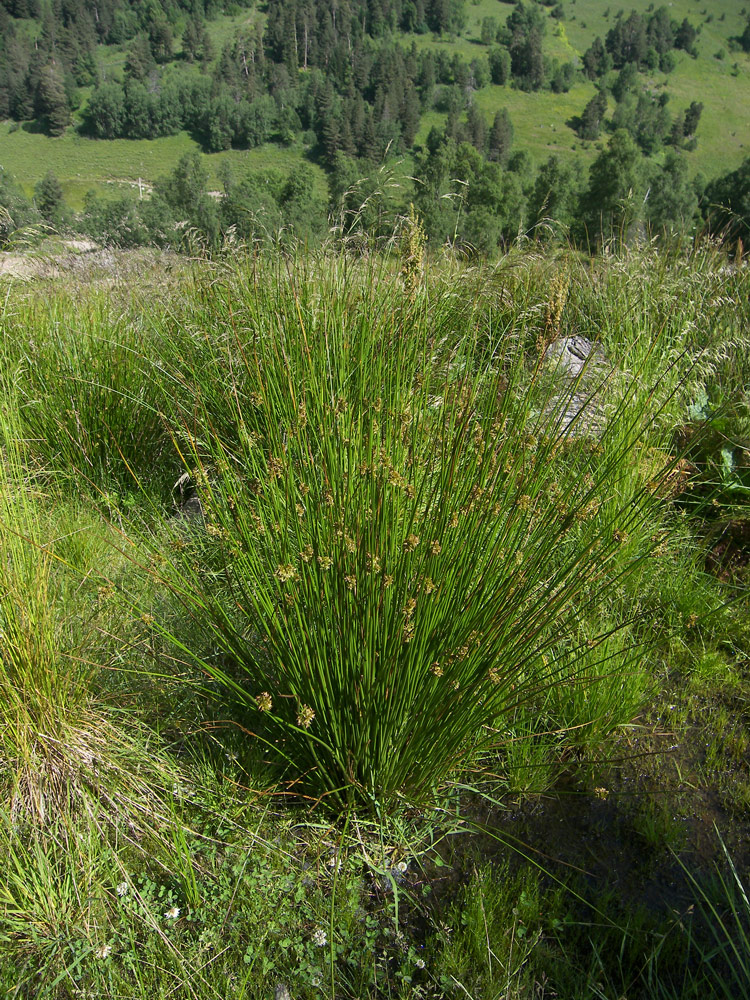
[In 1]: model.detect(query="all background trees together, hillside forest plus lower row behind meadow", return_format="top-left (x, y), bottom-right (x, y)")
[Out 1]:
top-left (0, 0), bottom-right (750, 253)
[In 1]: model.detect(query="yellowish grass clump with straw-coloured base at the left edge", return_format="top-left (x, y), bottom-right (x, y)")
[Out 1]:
top-left (0, 371), bottom-right (177, 829)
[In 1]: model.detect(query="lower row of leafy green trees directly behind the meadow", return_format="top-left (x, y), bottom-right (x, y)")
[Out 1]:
top-left (5, 128), bottom-right (750, 256)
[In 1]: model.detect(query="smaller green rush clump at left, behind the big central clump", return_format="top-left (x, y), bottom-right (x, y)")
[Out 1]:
top-left (0, 275), bottom-right (176, 505)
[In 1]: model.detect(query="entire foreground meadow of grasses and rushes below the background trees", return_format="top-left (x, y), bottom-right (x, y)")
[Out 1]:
top-left (0, 236), bottom-right (750, 1000)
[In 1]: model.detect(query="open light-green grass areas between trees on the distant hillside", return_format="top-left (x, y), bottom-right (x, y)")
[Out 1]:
top-left (0, 0), bottom-right (750, 208)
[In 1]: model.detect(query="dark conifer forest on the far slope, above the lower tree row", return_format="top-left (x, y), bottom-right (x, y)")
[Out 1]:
top-left (0, 0), bottom-right (712, 165)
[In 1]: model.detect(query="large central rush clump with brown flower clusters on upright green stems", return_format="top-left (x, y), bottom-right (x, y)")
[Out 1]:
top-left (119, 250), bottom-right (692, 811)
